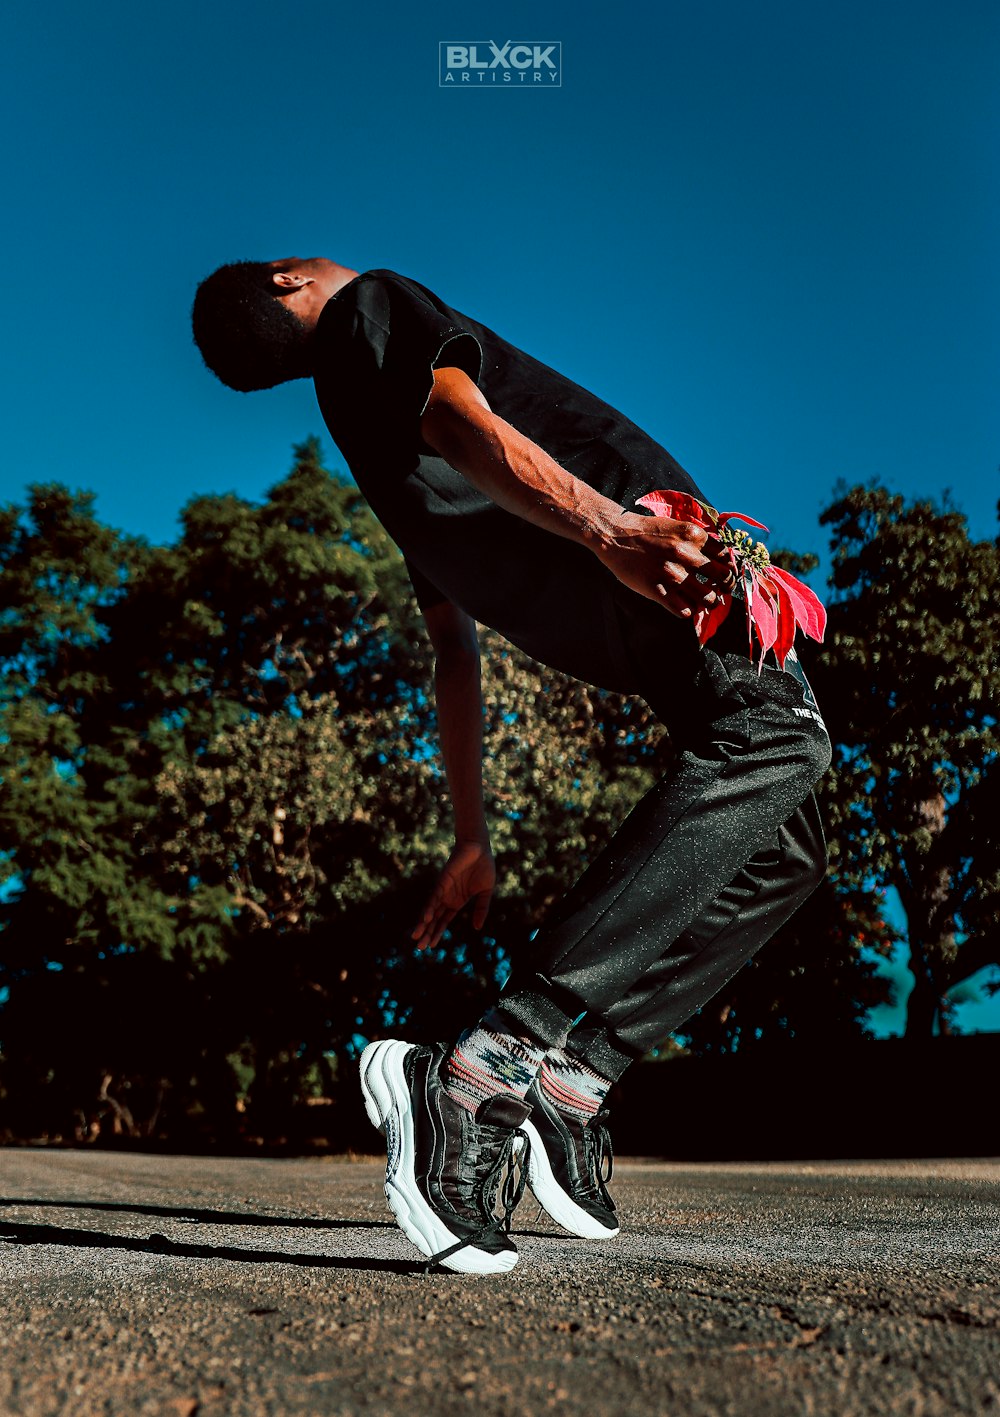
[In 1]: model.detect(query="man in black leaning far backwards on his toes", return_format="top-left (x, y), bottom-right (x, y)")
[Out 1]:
top-left (193, 258), bottom-right (829, 1274)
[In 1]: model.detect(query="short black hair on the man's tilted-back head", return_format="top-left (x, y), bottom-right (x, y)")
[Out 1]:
top-left (191, 261), bottom-right (306, 394)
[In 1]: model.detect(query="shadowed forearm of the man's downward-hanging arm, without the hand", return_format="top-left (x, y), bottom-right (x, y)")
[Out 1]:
top-left (433, 653), bottom-right (489, 842)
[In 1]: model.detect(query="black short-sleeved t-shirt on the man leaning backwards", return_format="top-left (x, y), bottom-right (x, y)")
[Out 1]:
top-left (314, 271), bottom-right (704, 690)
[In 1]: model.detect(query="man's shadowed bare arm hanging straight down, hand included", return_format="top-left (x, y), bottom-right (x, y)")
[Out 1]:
top-left (412, 601), bottom-right (496, 949)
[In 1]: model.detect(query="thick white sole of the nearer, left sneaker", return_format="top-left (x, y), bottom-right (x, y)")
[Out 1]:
top-left (361, 1039), bottom-right (517, 1274)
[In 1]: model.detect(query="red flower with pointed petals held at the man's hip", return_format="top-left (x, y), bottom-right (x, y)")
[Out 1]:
top-left (636, 492), bottom-right (826, 669)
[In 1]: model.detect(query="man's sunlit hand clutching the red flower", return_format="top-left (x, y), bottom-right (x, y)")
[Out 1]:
top-left (595, 512), bottom-right (732, 619)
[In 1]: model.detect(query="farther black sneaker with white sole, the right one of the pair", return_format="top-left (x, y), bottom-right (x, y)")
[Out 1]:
top-left (521, 1078), bottom-right (619, 1240)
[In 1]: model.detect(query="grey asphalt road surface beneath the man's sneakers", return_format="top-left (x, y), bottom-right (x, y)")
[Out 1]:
top-left (0, 1151), bottom-right (1000, 1417)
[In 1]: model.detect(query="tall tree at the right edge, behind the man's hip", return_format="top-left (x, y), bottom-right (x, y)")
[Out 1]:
top-left (816, 486), bottom-right (1000, 1037)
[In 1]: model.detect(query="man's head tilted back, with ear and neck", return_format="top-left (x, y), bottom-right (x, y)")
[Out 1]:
top-left (191, 256), bottom-right (357, 393)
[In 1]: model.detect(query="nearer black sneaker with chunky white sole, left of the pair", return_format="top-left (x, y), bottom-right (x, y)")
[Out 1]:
top-left (361, 1039), bottom-right (531, 1274)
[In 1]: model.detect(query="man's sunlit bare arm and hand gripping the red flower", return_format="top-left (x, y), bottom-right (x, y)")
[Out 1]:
top-left (421, 368), bottom-right (731, 618)
